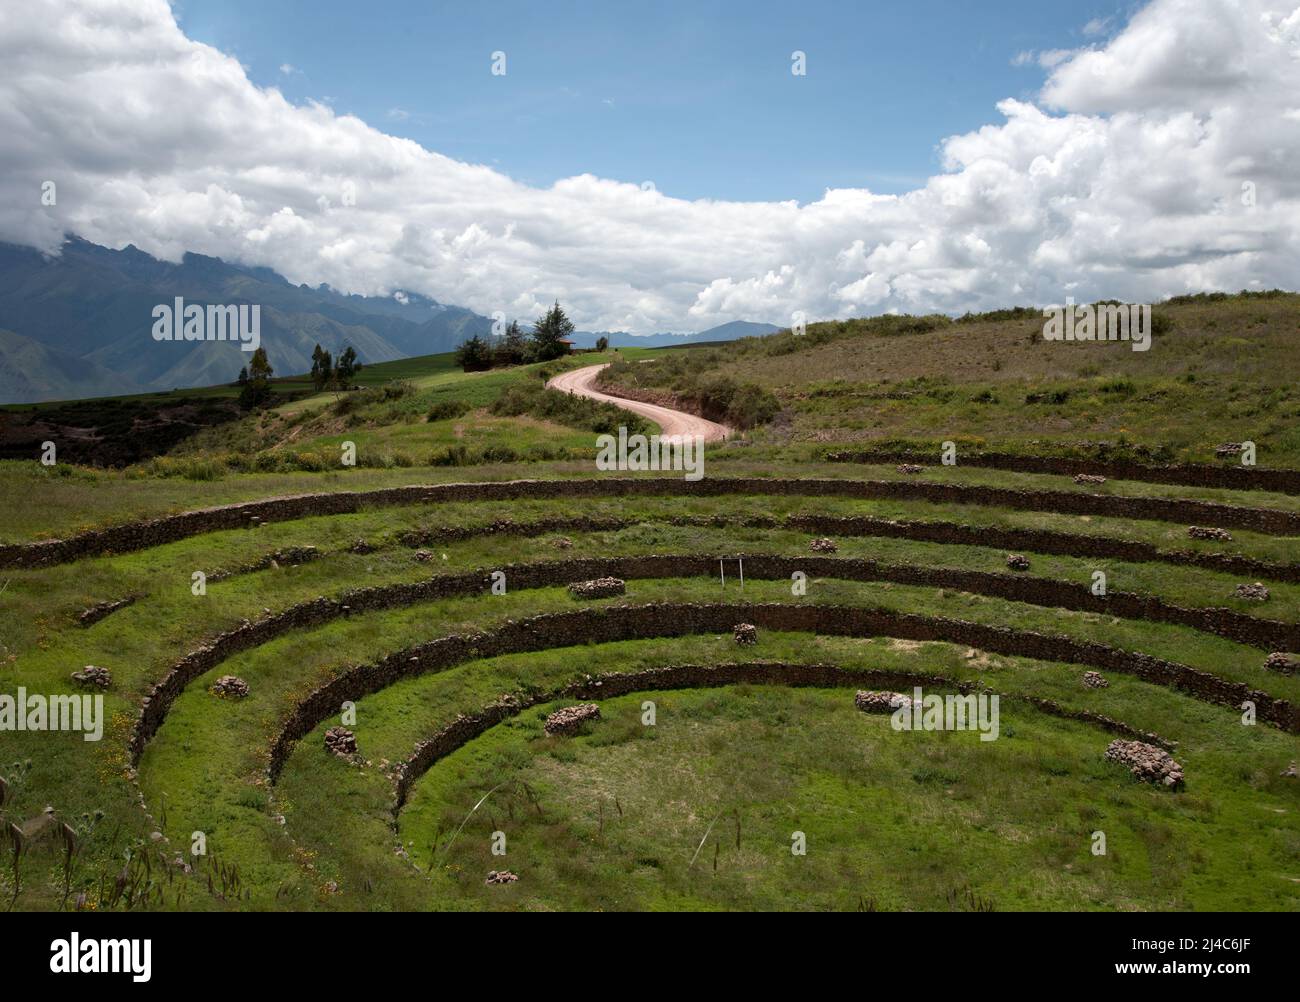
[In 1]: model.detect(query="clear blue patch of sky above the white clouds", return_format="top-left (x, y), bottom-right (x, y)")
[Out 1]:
top-left (176, 0), bottom-right (1126, 203)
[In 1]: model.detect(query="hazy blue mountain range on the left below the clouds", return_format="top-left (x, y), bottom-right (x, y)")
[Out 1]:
top-left (0, 238), bottom-right (491, 403)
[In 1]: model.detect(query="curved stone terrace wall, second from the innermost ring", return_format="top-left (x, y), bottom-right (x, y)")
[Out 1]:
top-left (268, 603), bottom-right (1300, 781)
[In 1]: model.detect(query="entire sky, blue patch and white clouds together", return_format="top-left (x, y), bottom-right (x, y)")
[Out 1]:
top-left (0, 0), bottom-right (1300, 333)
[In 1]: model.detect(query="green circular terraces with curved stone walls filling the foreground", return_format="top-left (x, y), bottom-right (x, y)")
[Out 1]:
top-left (0, 444), bottom-right (1300, 911)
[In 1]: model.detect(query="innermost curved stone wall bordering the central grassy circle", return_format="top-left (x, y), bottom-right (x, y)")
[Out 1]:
top-left (394, 662), bottom-right (1174, 814)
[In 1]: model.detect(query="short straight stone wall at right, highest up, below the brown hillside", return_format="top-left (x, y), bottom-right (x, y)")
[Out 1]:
top-left (826, 448), bottom-right (1300, 494)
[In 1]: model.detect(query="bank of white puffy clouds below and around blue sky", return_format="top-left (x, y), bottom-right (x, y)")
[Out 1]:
top-left (0, 0), bottom-right (1300, 333)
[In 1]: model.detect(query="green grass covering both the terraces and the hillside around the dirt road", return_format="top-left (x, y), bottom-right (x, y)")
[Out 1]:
top-left (0, 309), bottom-right (1300, 911)
